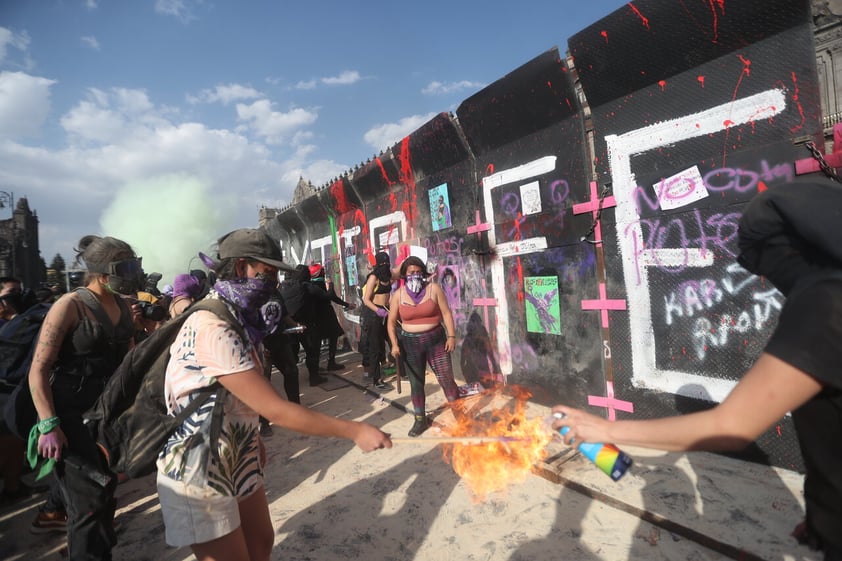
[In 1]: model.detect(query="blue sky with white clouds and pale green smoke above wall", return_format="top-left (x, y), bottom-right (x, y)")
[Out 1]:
top-left (0, 0), bottom-right (625, 282)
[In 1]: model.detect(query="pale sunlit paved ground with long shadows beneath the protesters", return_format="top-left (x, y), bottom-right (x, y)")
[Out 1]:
top-left (0, 355), bottom-right (820, 561)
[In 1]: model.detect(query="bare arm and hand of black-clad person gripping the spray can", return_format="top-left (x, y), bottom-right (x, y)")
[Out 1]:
top-left (553, 353), bottom-right (822, 451)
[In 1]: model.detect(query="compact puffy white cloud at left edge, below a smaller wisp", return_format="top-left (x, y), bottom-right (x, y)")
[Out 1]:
top-left (0, 72), bottom-right (55, 139)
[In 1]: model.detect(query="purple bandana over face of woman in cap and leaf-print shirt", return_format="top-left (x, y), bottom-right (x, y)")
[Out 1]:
top-left (213, 275), bottom-right (281, 344)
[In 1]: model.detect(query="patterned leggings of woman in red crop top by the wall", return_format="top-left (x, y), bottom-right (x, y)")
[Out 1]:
top-left (398, 325), bottom-right (459, 415)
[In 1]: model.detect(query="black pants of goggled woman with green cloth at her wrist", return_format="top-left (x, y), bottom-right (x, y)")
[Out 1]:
top-left (52, 376), bottom-right (117, 561)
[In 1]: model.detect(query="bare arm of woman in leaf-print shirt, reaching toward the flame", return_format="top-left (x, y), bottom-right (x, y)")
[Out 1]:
top-left (217, 368), bottom-right (392, 452)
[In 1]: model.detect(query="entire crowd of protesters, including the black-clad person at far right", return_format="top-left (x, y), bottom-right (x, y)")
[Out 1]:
top-left (0, 178), bottom-right (842, 561)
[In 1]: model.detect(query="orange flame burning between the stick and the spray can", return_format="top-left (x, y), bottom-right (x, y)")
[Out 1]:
top-left (443, 385), bottom-right (553, 502)
